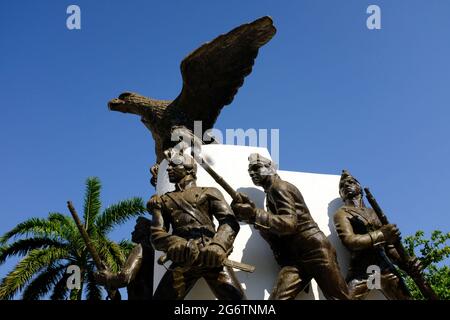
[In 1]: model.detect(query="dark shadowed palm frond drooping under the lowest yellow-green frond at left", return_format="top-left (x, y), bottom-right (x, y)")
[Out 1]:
top-left (22, 264), bottom-right (66, 300)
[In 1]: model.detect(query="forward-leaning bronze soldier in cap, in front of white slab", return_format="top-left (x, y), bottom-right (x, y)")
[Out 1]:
top-left (231, 154), bottom-right (349, 300)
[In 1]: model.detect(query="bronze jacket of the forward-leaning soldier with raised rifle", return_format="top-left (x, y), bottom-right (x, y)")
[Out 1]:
top-left (251, 175), bottom-right (326, 265)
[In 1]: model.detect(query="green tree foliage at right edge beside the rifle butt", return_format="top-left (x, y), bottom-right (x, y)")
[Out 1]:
top-left (403, 230), bottom-right (450, 300)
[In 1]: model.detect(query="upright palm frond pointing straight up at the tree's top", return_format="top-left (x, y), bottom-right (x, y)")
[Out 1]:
top-left (83, 177), bottom-right (102, 232)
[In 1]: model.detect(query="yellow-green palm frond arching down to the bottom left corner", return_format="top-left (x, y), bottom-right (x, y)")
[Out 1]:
top-left (0, 247), bottom-right (69, 300)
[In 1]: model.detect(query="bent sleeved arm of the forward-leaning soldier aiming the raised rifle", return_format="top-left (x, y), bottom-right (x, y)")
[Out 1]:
top-left (255, 189), bottom-right (297, 235)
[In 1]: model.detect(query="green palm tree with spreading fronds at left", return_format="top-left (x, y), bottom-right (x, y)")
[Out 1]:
top-left (0, 177), bottom-right (145, 300)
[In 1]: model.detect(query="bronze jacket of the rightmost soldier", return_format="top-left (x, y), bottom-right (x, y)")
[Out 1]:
top-left (334, 206), bottom-right (398, 279)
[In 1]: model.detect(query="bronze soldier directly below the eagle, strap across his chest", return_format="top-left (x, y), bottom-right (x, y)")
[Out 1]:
top-left (147, 149), bottom-right (245, 300)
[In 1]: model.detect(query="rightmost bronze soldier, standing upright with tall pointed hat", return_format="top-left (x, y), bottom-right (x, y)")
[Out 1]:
top-left (334, 170), bottom-right (420, 300)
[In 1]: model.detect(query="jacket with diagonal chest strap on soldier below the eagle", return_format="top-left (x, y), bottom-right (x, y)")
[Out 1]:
top-left (149, 176), bottom-right (239, 253)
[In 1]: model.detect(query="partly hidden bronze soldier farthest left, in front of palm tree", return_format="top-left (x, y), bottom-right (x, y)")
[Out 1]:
top-left (94, 217), bottom-right (155, 300)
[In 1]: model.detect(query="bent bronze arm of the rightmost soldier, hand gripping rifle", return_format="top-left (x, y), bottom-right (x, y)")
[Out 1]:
top-left (334, 210), bottom-right (385, 251)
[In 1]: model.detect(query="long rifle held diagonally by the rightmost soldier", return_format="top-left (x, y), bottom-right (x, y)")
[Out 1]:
top-left (364, 188), bottom-right (439, 300)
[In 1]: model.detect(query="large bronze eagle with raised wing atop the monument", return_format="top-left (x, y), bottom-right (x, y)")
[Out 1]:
top-left (108, 17), bottom-right (276, 184)
